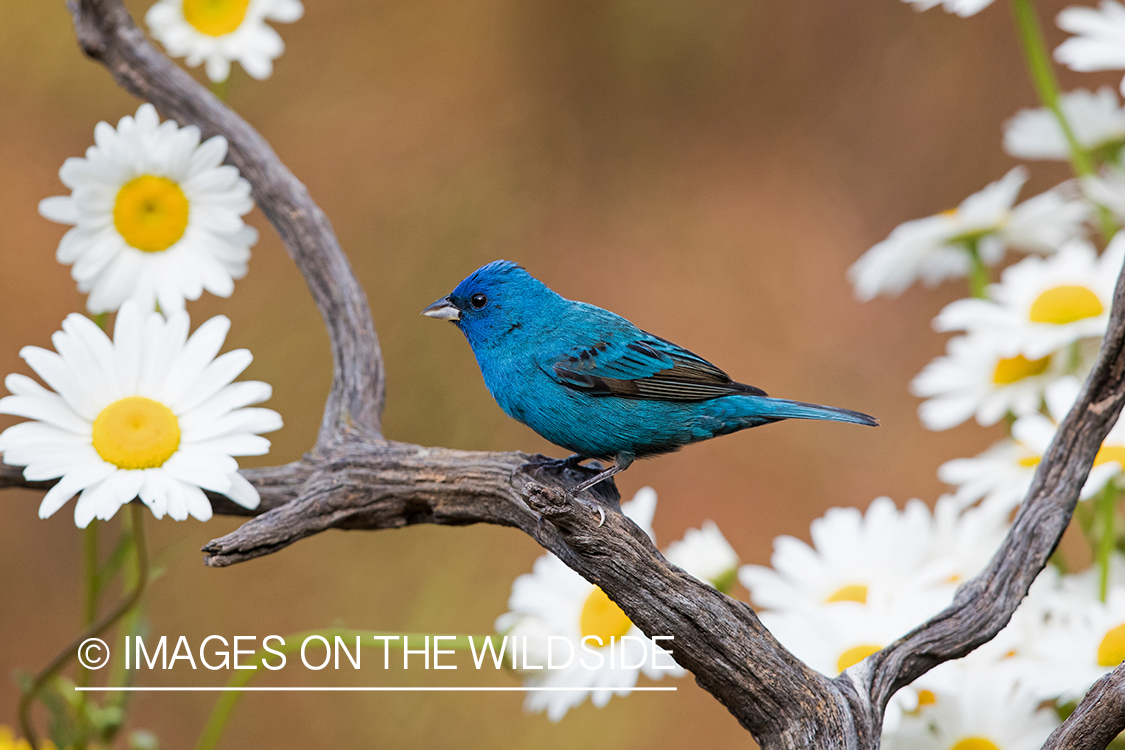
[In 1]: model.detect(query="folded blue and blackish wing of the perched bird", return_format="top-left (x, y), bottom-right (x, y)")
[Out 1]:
top-left (540, 331), bottom-right (766, 401)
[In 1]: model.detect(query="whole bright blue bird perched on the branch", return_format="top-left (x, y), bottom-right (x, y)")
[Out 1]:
top-left (422, 261), bottom-right (879, 494)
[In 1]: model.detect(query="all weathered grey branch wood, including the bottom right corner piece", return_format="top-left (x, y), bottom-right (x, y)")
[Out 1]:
top-left (0, 0), bottom-right (1125, 749)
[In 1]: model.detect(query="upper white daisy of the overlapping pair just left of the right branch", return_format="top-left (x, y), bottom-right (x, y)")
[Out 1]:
top-left (738, 497), bottom-right (951, 614)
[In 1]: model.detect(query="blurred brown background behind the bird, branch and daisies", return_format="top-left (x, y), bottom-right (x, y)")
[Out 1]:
top-left (0, 0), bottom-right (1116, 748)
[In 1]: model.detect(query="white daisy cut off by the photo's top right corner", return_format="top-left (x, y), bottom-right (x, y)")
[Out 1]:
top-left (1054, 0), bottom-right (1125, 93)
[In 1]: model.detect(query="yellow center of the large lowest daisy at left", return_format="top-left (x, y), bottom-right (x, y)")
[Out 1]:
top-left (93, 396), bottom-right (180, 469)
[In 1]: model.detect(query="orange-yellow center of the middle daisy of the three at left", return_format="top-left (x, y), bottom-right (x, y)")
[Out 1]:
top-left (114, 174), bottom-right (188, 253)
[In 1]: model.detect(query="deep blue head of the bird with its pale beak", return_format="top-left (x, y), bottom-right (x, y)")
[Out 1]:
top-left (422, 261), bottom-right (566, 350)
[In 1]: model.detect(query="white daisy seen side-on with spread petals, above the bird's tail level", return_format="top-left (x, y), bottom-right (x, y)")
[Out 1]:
top-left (848, 166), bottom-right (1089, 300)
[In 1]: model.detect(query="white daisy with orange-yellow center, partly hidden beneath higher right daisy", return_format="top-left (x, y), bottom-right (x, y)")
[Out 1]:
top-left (910, 333), bottom-right (1068, 430)
